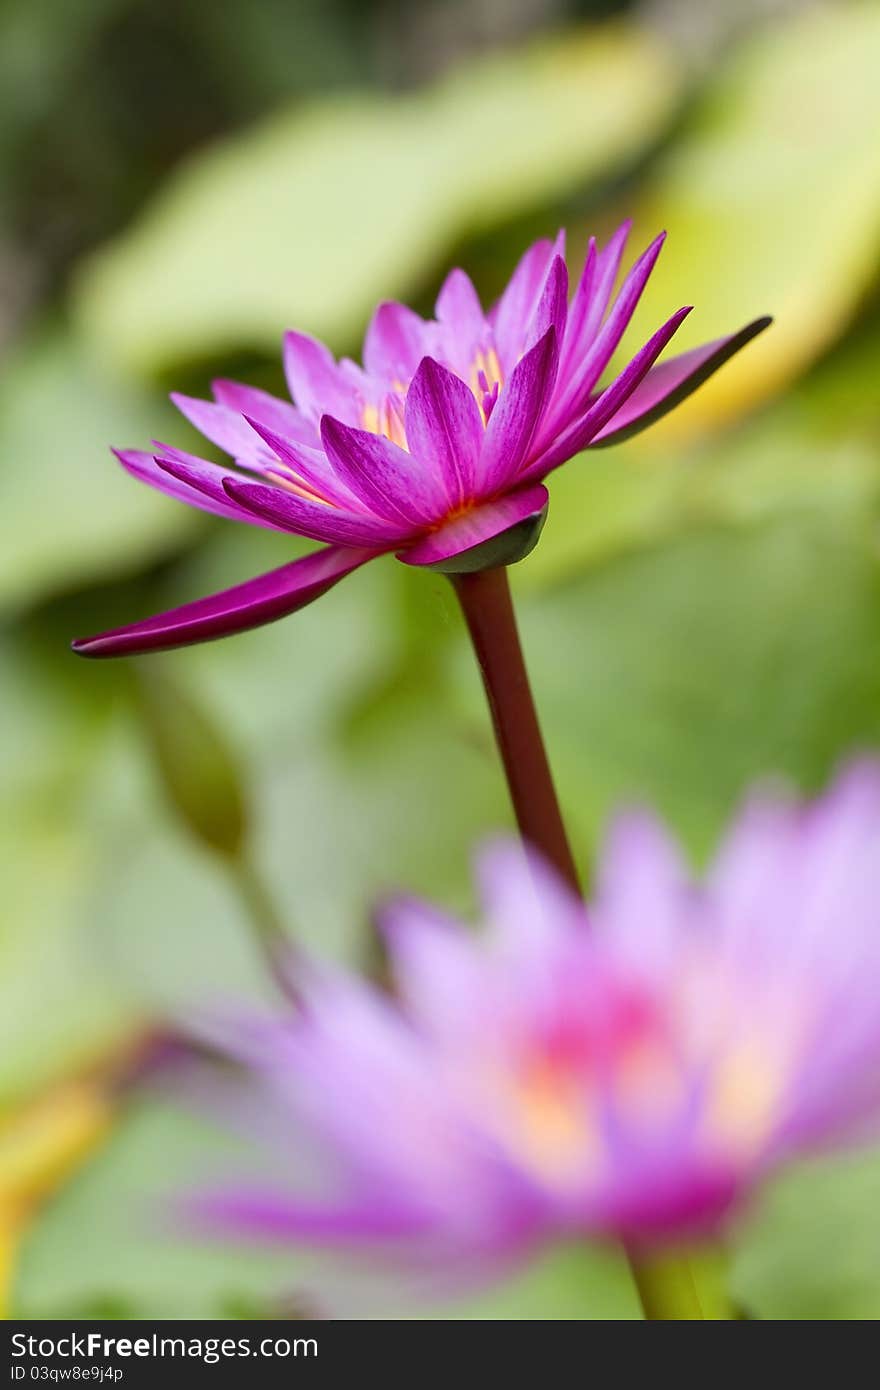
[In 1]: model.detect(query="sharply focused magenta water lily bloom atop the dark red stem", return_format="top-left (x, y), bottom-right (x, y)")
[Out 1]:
top-left (74, 225), bottom-right (769, 656)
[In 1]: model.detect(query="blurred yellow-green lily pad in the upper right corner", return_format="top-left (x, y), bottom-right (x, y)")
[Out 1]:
top-left (614, 0), bottom-right (880, 441)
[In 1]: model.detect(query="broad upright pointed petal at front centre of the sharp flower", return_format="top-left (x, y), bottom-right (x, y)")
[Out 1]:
top-left (406, 357), bottom-right (482, 509)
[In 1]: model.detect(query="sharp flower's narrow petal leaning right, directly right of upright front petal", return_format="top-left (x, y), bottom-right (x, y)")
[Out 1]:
top-left (480, 328), bottom-right (559, 492)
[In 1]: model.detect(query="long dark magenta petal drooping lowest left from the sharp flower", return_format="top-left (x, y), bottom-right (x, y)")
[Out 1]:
top-left (72, 548), bottom-right (374, 656)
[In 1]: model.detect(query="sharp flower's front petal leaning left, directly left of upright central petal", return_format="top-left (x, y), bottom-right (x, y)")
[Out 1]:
top-left (321, 416), bottom-right (449, 535)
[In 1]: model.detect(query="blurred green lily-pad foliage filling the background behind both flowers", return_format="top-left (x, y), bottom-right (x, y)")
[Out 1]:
top-left (0, 0), bottom-right (880, 1319)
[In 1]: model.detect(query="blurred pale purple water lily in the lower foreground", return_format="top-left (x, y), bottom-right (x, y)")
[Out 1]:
top-left (199, 762), bottom-right (880, 1273)
